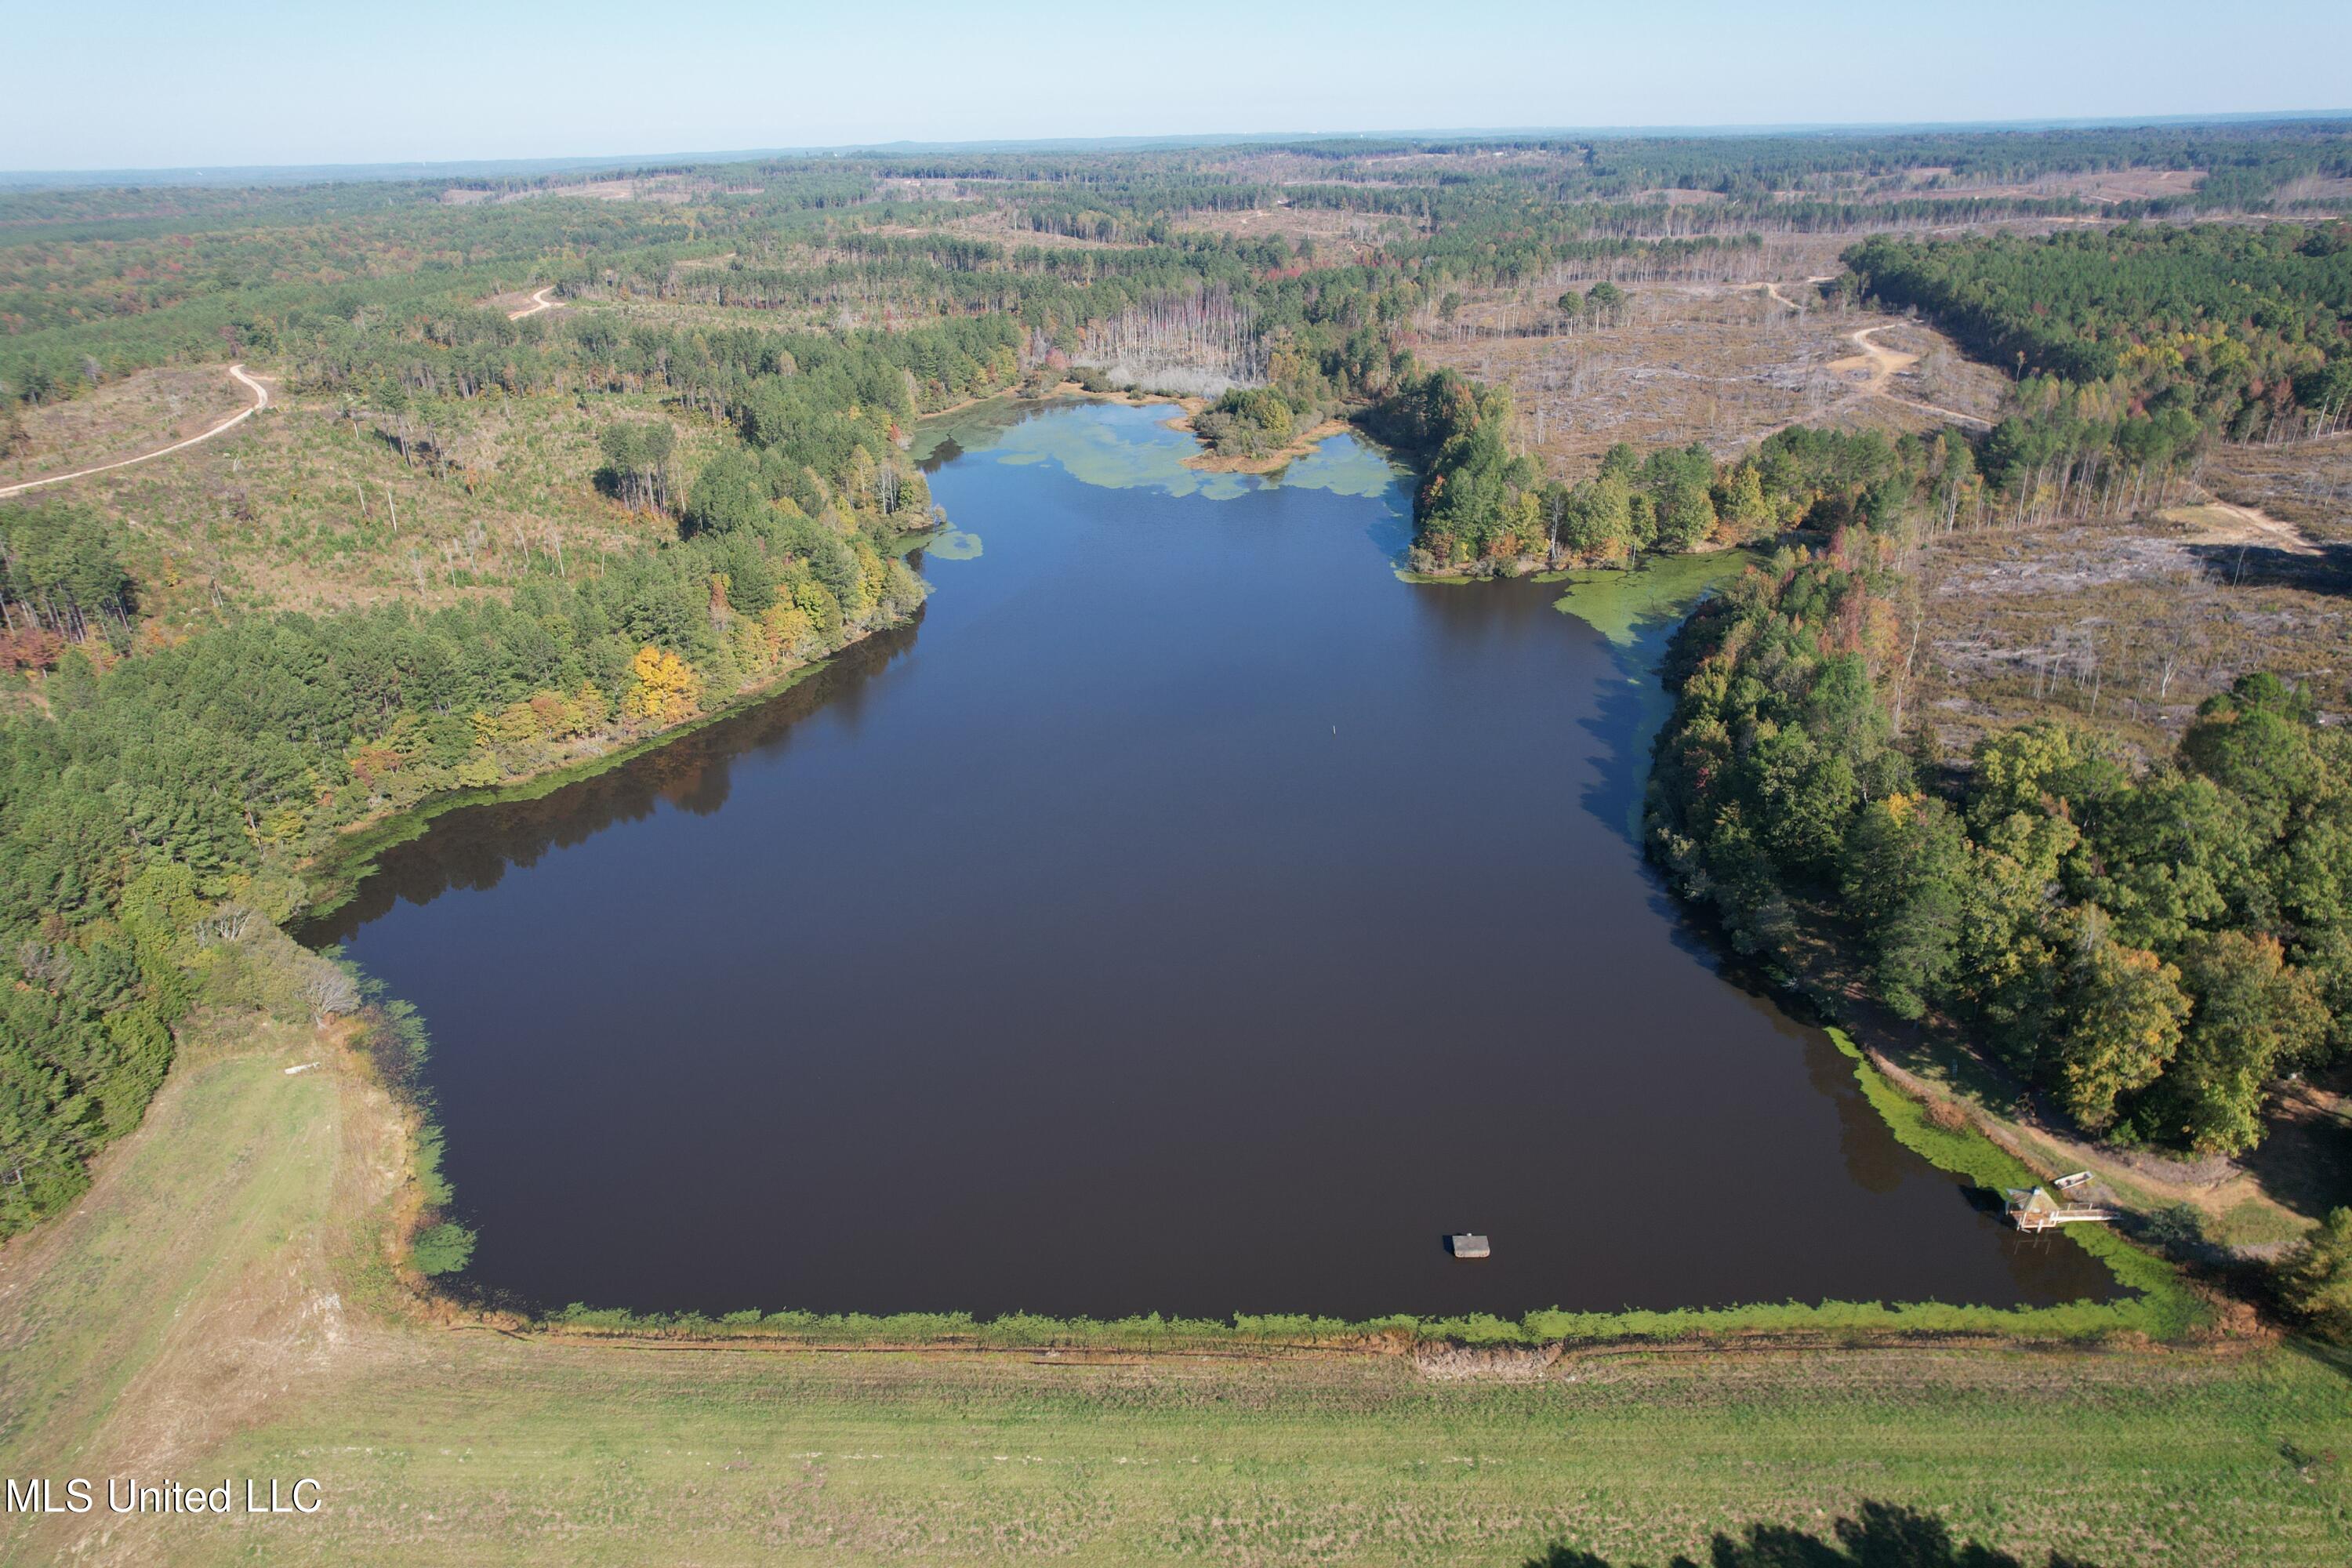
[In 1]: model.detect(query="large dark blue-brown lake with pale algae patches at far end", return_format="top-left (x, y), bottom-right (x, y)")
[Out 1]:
top-left (310, 405), bottom-right (2112, 1316)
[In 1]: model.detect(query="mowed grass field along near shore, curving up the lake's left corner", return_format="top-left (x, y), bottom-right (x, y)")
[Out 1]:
top-left (0, 1020), bottom-right (2352, 1563)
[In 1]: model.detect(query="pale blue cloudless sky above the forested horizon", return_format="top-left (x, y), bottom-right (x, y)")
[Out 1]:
top-left (0, 0), bottom-right (2352, 169)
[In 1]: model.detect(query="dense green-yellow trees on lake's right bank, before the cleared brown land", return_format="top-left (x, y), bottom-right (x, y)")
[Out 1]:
top-left (1649, 532), bottom-right (2352, 1154)
